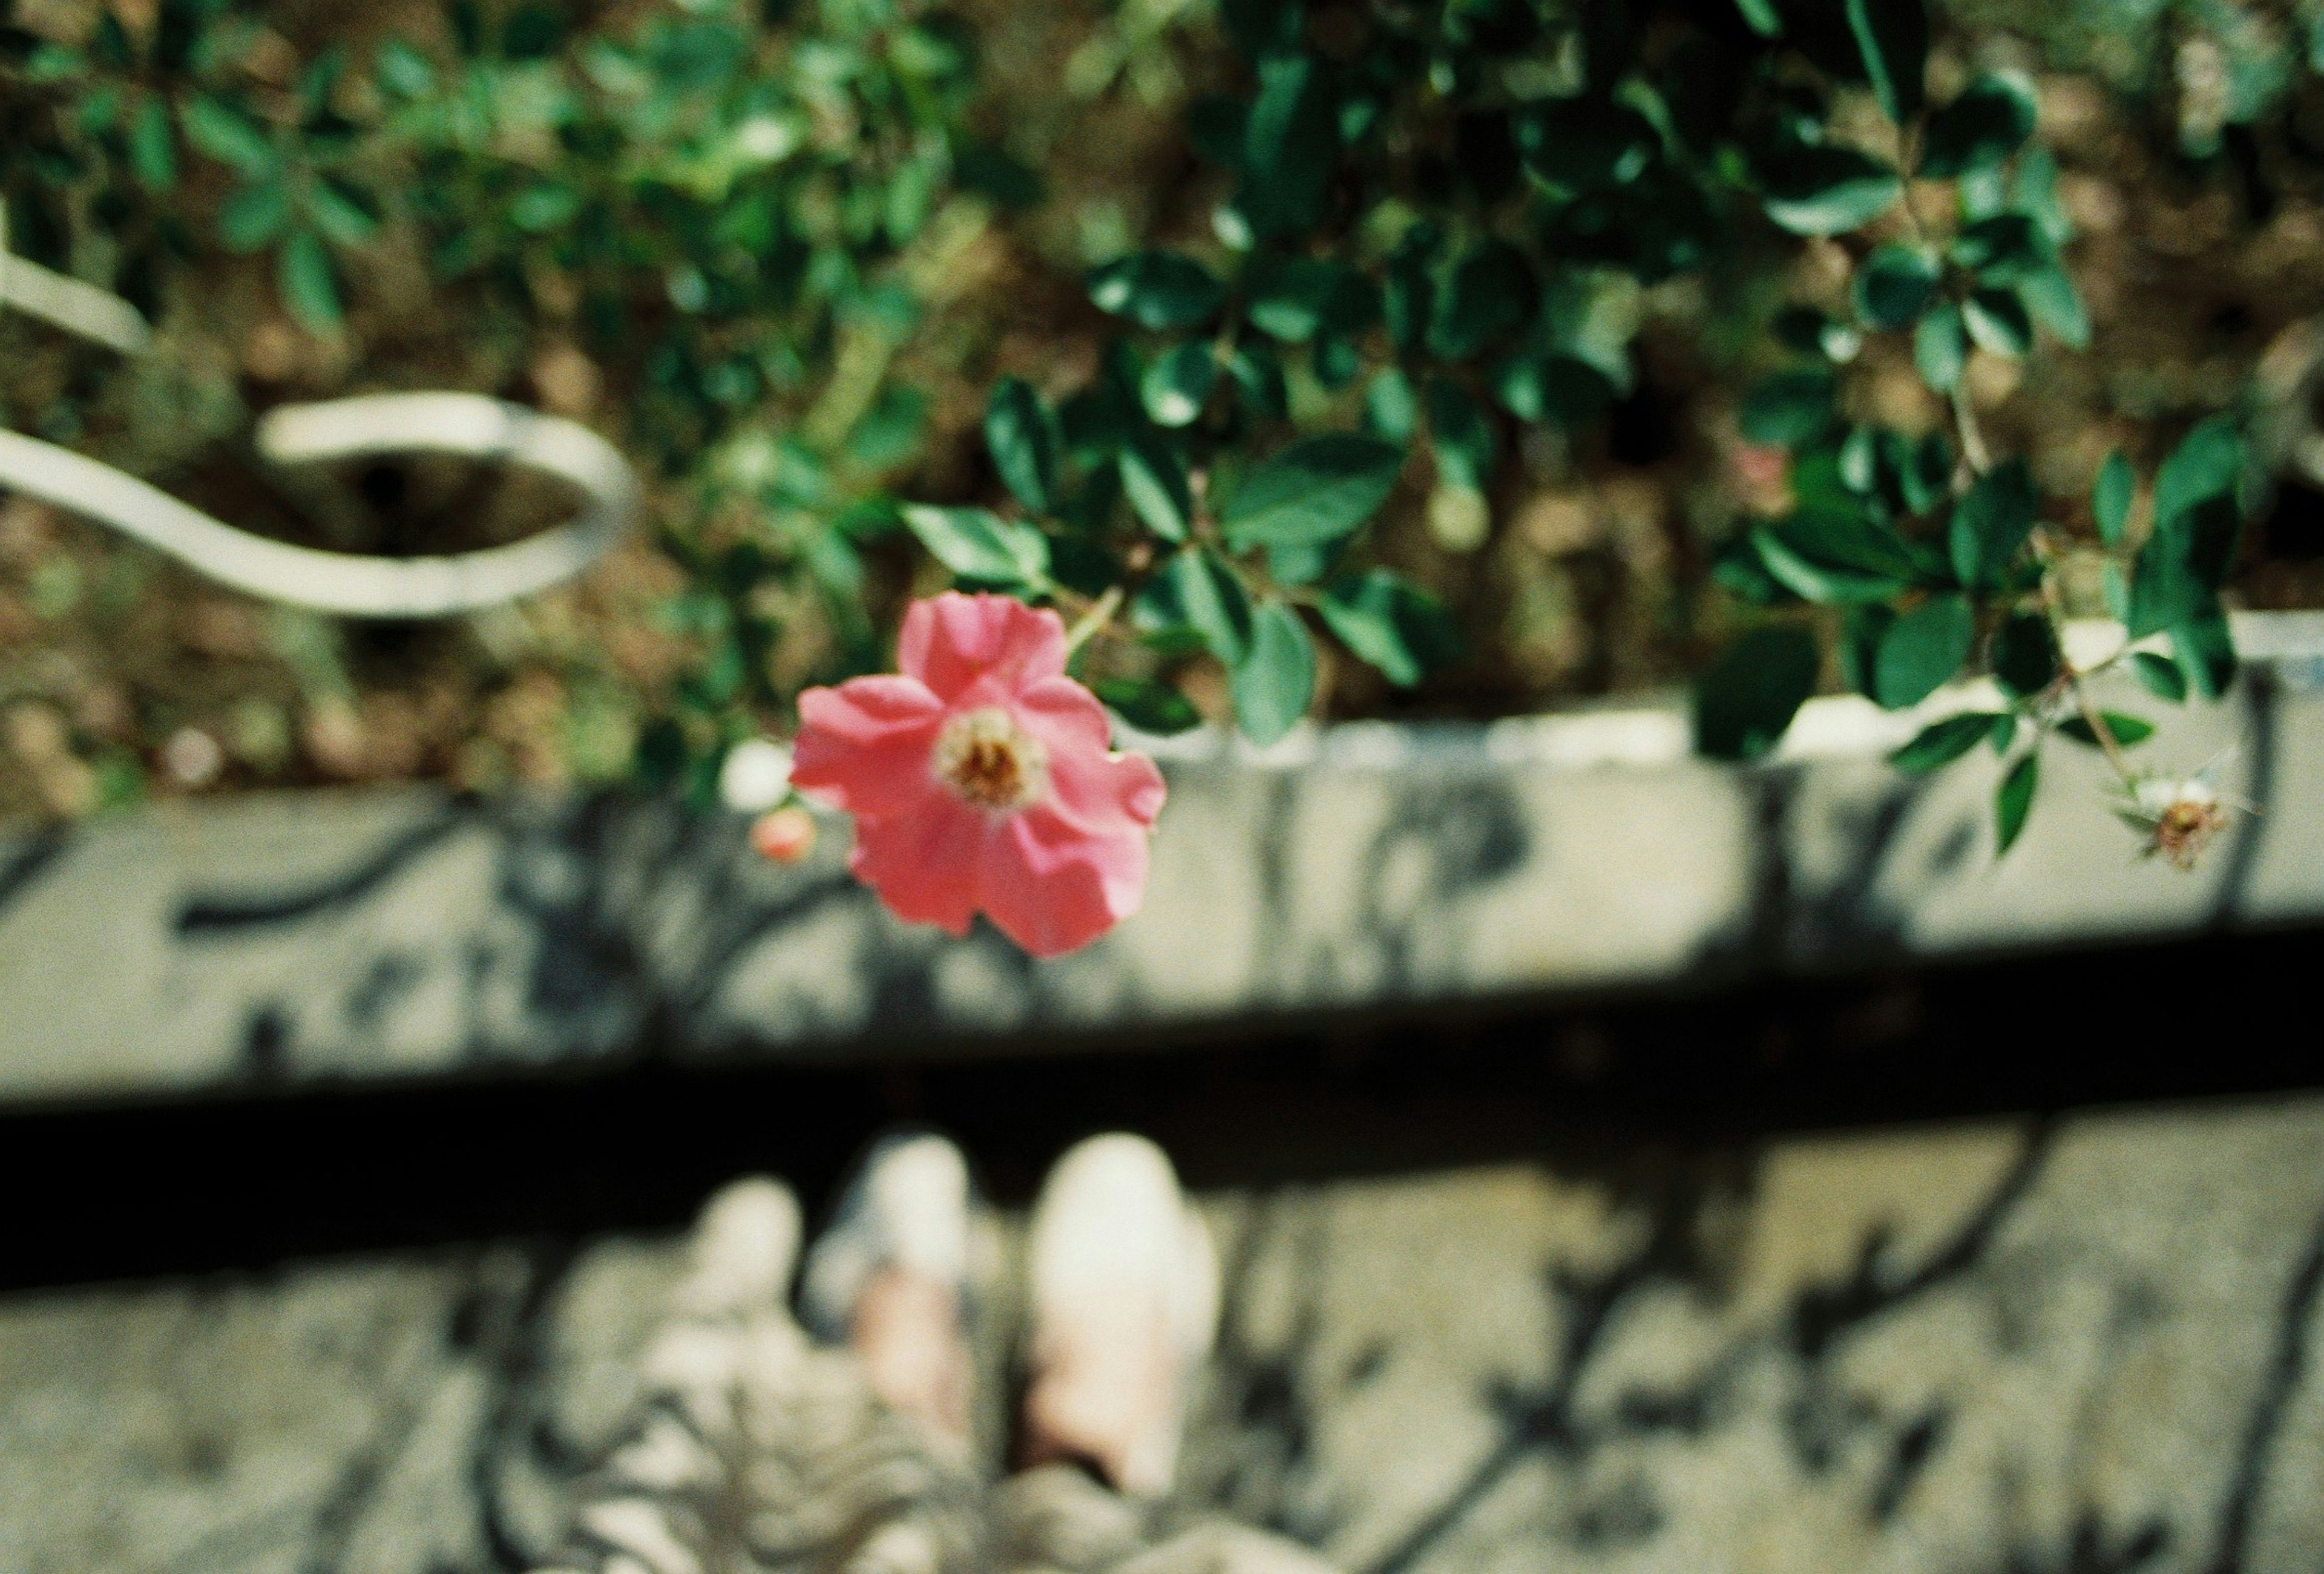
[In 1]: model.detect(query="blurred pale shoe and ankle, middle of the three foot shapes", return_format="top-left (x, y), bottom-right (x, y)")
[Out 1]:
top-left (799, 1135), bottom-right (974, 1458)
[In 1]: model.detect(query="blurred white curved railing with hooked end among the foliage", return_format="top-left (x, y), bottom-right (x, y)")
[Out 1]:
top-left (0, 232), bottom-right (639, 618)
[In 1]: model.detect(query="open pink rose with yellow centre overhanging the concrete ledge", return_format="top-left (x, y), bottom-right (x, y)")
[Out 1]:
top-left (790, 591), bottom-right (1162, 956)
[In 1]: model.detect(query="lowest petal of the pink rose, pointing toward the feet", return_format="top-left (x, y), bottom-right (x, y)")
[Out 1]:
top-left (976, 809), bottom-right (1146, 958)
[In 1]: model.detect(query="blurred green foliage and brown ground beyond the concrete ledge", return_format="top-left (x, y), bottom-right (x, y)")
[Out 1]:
top-left (0, 0), bottom-right (2324, 814)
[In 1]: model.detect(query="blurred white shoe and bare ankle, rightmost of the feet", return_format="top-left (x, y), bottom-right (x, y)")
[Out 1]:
top-left (1023, 1132), bottom-right (1218, 1497)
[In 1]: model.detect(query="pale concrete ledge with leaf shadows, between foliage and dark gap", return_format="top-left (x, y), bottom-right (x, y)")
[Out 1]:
top-left (0, 614), bottom-right (2324, 1102)
